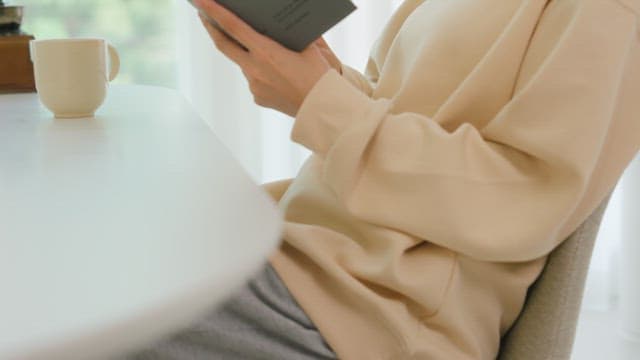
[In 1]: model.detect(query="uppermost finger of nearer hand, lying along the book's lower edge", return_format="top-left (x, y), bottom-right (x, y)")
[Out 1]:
top-left (195, 0), bottom-right (269, 50)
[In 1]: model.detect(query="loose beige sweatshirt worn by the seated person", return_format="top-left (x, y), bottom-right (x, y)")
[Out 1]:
top-left (270, 0), bottom-right (640, 360)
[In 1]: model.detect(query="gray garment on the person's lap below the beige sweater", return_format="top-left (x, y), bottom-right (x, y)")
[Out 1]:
top-left (124, 264), bottom-right (337, 360)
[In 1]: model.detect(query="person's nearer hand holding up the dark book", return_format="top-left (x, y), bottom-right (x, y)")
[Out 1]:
top-left (195, 0), bottom-right (331, 116)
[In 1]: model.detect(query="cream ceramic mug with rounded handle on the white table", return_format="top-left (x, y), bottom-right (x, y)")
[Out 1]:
top-left (29, 39), bottom-right (120, 118)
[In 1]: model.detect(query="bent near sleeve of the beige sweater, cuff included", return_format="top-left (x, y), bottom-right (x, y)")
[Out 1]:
top-left (292, 9), bottom-right (638, 261)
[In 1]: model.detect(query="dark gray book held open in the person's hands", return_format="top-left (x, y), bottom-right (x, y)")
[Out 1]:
top-left (188, 0), bottom-right (356, 52)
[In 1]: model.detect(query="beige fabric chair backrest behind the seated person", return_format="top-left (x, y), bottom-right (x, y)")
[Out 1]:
top-left (498, 195), bottom-right (611, 360)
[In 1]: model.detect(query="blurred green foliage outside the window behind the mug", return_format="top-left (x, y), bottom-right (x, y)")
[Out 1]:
top-left (15, 0), bottom-right (176, 87)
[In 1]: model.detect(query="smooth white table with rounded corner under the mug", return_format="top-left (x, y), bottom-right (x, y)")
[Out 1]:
top-left (0, 86), bottom-right (281, 360)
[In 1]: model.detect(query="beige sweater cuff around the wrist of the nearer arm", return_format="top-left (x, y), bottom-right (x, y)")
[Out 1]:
top-left (291, 69), bottom-right (372, 154)
